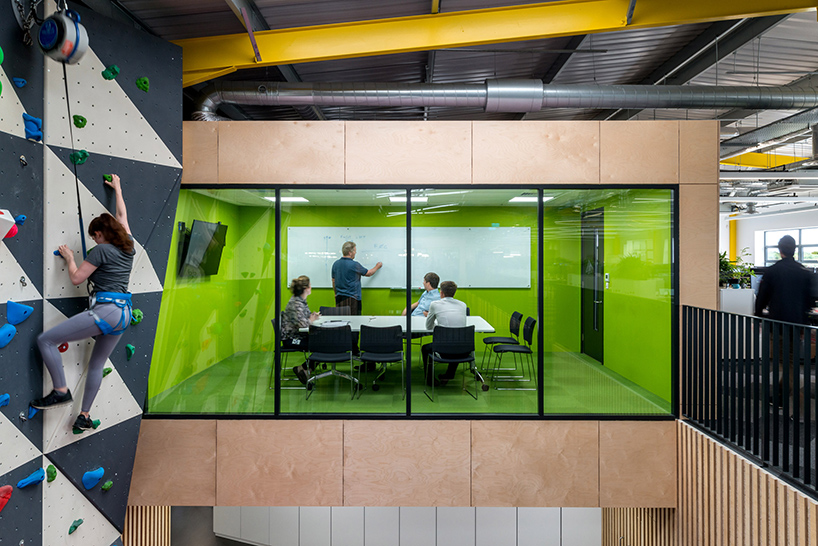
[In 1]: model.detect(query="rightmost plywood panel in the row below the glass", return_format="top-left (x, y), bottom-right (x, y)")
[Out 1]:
top-left (599, 421), bottom-right (676, 508)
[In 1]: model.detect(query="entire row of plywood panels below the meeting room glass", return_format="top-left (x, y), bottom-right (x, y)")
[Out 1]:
top-left (130, 419), bottom-right (676, 507)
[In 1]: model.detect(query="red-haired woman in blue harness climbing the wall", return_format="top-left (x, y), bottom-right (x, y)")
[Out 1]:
top-left (31, 174), bottom-right (136, 430)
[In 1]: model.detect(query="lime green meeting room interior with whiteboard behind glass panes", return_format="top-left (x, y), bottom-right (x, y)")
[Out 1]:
top-left (143, 187), bottom-right (676, 415)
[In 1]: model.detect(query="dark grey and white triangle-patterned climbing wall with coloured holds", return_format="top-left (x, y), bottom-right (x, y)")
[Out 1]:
top-left (0, 2), bottom-right (182, 546)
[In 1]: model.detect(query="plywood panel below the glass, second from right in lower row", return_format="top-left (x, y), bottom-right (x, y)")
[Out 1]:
top-left (472, 421), bottom-right (599, 507)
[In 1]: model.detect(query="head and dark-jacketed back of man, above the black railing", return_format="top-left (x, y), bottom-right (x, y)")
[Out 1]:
top-left (755, 236), bottom-right (813, 324)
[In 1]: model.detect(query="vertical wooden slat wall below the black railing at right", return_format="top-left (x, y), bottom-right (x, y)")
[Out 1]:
top-left (676, 422), bottom-right (818, 546)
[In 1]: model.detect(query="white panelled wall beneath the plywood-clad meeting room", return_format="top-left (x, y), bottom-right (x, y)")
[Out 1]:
top-left (213, 506), bottom-right (602, 546)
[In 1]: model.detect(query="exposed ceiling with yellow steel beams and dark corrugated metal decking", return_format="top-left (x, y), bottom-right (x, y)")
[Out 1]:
top-left (73, 0), bottom-right (818, 216)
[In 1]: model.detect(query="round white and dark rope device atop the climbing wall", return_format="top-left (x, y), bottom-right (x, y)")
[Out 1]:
top-left (11, 0), bottom-right (88, 64)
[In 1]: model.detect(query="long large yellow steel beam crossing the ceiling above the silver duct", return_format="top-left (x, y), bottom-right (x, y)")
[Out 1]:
top-left (174, 0), bottom-right (818, 86)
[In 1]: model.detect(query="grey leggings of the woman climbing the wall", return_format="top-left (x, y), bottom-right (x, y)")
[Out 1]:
top-left (37, 303), bottom-right (130, 412)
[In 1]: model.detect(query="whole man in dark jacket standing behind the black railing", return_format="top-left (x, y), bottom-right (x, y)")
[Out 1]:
top-left (755, 235), bottom-right (815, 415)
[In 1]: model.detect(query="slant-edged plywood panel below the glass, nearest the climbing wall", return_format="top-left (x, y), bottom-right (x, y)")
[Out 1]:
top-left (128, 419), bottom-right (216, 506)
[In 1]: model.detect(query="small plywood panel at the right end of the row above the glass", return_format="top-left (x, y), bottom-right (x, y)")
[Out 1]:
top-left (679, 121), bottom-right (719, 184)
